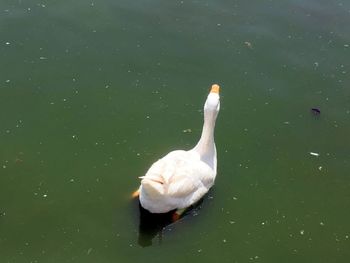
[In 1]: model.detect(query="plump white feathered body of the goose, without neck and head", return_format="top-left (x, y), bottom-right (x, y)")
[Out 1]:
top-left (140, 150), bottom-right (216, 213)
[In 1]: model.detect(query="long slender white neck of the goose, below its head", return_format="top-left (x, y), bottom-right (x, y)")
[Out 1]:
top-left (194, 112), bottom-right (216, 157)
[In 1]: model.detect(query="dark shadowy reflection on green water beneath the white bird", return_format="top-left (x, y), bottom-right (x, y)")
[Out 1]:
top-left (138, 200), bottom-right (203, 247)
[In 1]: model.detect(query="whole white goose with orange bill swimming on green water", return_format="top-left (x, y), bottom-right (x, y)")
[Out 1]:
top-left (133, 84), bottom-right (220, 219)
